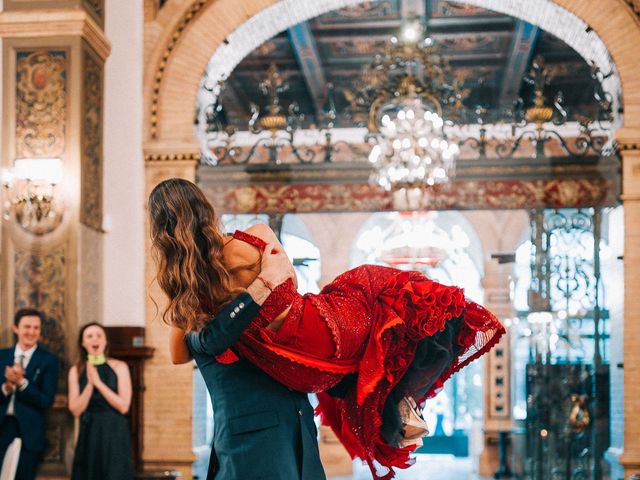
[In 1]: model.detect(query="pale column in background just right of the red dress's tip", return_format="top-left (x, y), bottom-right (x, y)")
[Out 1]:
top-left (479, 260), bottom-right (514, 477)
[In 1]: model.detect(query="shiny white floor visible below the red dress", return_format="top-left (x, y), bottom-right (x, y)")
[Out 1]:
top-left (329, 455), bottom-right (485, 480)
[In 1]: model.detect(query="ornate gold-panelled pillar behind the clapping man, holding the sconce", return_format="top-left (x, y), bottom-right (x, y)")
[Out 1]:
top-left (0, 0), bottom-right (110, 475)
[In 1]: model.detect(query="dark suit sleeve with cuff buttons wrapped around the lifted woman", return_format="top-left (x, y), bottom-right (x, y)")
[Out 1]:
top-left (185, 293), bottom-right (261, 356)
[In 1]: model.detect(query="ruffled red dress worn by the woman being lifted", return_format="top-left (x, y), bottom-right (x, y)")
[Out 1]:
top-left (218, 231), bottom-right (505, 479)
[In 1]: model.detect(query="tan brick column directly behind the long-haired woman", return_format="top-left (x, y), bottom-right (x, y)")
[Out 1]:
top-left (142, 146), bottom-right (199, 480)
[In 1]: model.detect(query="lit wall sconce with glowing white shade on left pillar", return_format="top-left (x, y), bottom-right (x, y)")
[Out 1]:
top-left (2, 158), bottom-right (64, 235)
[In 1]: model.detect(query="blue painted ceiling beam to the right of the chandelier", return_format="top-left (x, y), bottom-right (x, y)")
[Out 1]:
top-left (498, 20), bottom-right (540, 109)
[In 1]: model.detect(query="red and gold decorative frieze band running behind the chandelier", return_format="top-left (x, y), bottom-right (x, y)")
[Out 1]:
top-left (200, 179), bottom-right (617, 213)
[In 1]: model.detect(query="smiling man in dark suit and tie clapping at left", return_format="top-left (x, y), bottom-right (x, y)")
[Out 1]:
top-left (0, 308), bottom-right (58, 480)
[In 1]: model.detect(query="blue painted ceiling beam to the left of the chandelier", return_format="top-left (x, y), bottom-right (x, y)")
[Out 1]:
top-left (287, 22), bottom-right (328, 117)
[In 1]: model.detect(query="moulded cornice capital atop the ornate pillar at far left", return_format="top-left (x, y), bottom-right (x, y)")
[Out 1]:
top-left (0, 9), bottom-right (111, 60)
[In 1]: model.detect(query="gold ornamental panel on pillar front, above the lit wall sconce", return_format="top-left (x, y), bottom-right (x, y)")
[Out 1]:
top-left (15, 50), bottom-right (68, 158)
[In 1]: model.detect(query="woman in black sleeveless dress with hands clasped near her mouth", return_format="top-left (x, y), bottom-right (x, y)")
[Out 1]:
top-left (69, 323), bottom-right (133, 480)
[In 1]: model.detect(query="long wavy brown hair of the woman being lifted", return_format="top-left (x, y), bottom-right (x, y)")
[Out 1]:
top-left (149, 178), bottom-right (243, 330)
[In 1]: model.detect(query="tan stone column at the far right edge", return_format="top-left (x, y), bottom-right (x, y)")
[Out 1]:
top-left (612, 127), bottom-right (640, 478)
